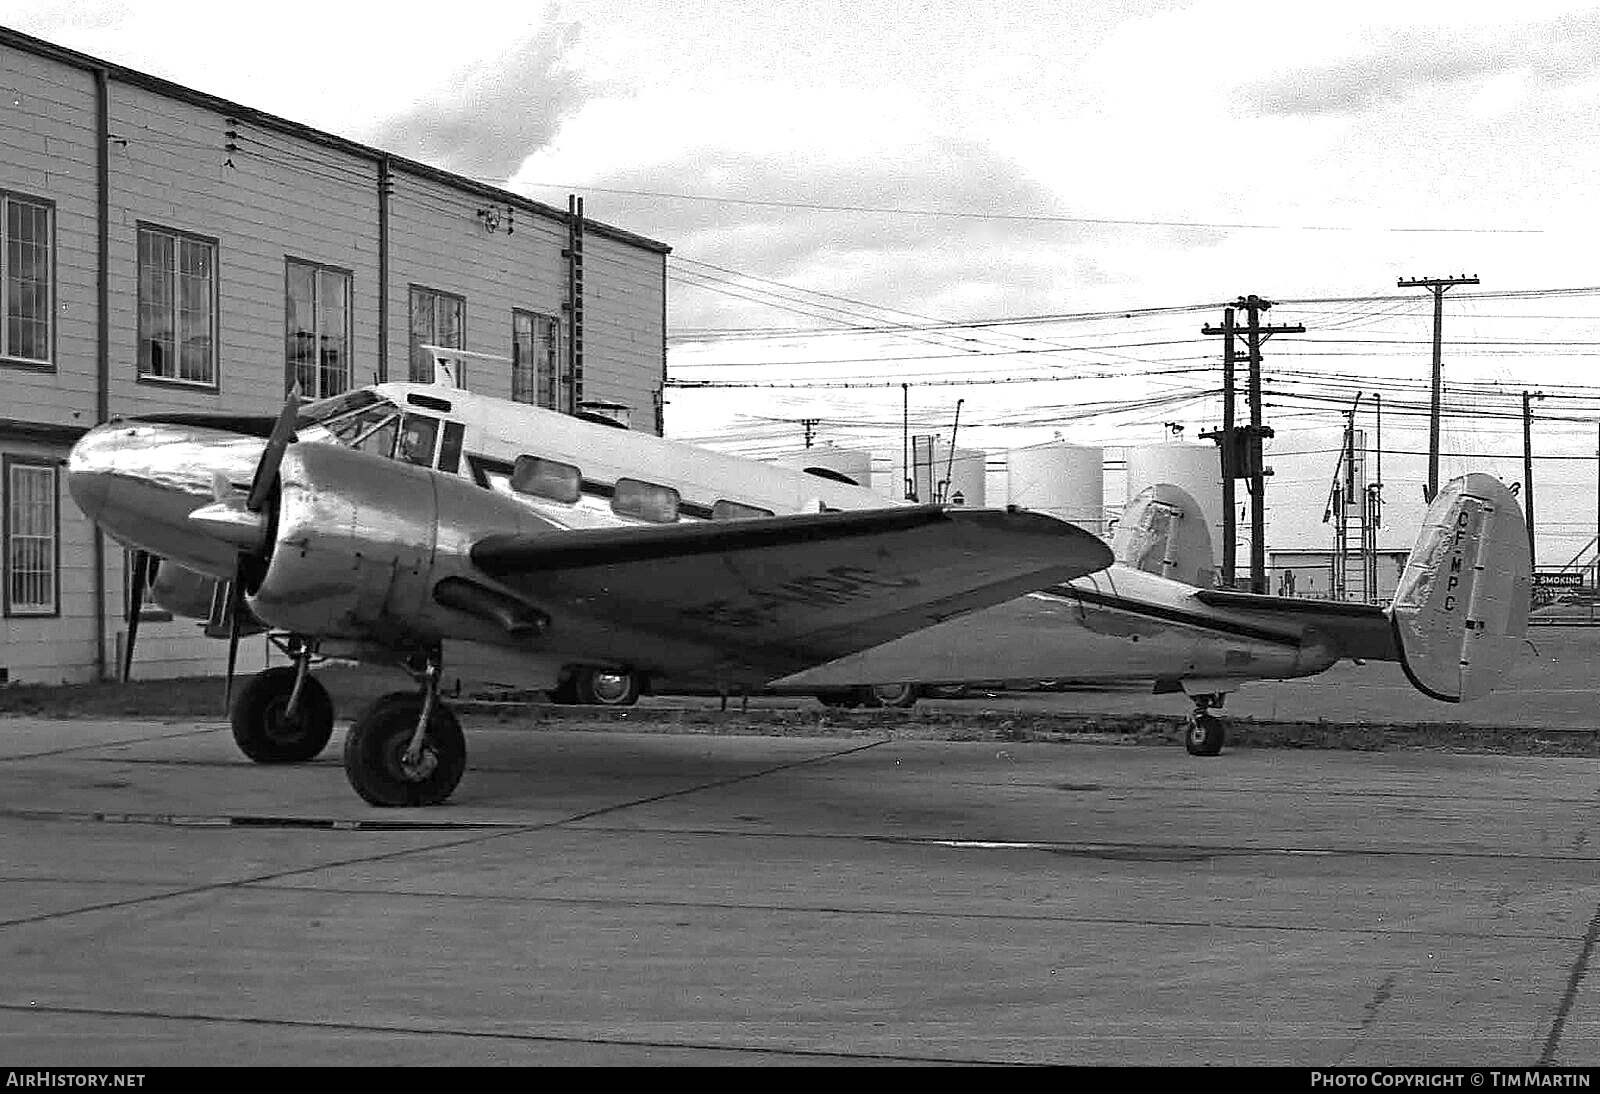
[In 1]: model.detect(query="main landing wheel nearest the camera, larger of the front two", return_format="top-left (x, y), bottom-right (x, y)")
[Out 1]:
top-left (344, 691), bottom-right (467, 808)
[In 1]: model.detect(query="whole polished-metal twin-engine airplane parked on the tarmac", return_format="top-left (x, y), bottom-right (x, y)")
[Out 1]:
top-left (69, 350), bottom-right (1530, 805)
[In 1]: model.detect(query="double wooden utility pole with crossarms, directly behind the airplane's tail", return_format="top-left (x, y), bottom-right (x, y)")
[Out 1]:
top-left (1202, 294), bottom-right (1306, 593)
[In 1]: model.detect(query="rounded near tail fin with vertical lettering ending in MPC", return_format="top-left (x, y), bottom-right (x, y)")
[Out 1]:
top-left (1389, 473), bottom-right (1533, 702)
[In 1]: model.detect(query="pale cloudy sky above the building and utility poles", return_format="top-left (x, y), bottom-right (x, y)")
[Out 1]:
top-left (9, 0), bottom-right (1600, 563)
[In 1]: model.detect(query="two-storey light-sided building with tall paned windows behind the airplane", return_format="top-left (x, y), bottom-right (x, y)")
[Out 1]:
top-left (0, 27), bottom-right (669, 683)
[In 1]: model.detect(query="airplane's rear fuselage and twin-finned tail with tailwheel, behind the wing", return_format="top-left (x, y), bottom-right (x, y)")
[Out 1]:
top-left (774, 473), bottom-right (1533, 755)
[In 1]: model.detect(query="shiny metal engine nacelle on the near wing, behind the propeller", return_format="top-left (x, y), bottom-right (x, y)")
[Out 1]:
top-left (248, 445), bottom-right (558, 649)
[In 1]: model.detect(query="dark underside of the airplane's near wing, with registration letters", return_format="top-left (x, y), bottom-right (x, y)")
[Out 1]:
top-left (472, 505), bottom-right (1112, 681)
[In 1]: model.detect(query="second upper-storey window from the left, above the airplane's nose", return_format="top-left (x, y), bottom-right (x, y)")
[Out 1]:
top-left (139, 226), bottom-right (216, 385)
